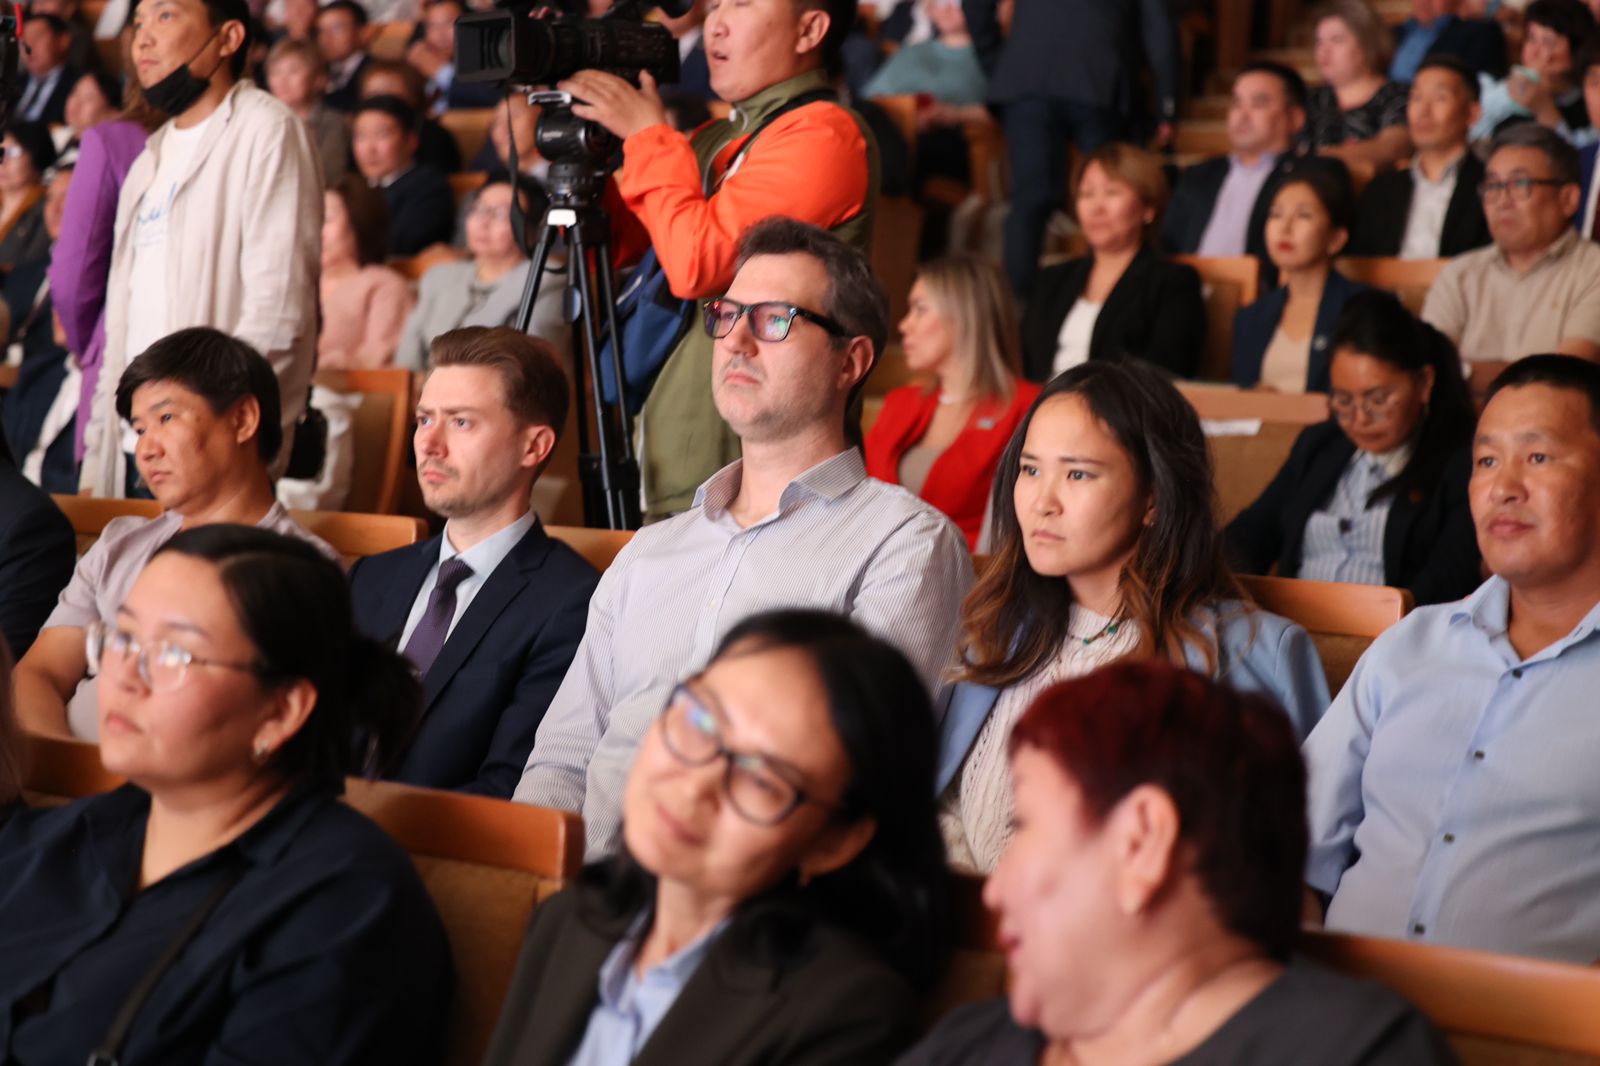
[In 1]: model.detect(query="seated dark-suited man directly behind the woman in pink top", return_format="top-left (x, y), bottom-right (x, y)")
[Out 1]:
top-left (350, 96), bottom-right (456, 256)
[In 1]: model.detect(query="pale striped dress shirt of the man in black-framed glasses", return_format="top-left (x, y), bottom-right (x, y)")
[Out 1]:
top-left (515, 448), bottom-right (973, 860)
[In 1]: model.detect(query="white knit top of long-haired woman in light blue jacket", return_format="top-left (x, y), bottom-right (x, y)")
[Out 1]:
top-left (939, 603), bottom-right (1139, 874)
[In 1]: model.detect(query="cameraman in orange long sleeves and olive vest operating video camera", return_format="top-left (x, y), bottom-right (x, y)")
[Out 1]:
top-left (558, 0), bottom-right (878, 517)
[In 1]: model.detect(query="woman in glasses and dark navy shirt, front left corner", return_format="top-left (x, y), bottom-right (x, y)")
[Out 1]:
top-left (0, 525), bottom-right (453, 1066)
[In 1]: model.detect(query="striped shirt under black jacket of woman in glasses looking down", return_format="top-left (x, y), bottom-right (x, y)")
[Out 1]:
top-left (1294, 443), bottom-right (1413, 584)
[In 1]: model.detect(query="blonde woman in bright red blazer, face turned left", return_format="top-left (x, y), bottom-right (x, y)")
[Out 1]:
top-left (866, 256), bottom-right (1038, 549)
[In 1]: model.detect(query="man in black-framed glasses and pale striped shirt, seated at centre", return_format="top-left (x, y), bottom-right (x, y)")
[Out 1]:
top-left (515, 218), bottom-right (973, 860)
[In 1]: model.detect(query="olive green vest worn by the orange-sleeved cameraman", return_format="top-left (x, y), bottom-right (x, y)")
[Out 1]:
top-left (638, 70), bottom-right (878, 520)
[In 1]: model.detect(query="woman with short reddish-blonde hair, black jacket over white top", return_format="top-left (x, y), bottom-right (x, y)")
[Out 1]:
top-left (1022, 142), bottom-right (1205, 384)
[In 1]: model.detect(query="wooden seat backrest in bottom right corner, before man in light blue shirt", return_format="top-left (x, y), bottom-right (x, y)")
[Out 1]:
top-left (1301, 932), bottom-right (1600, 1066)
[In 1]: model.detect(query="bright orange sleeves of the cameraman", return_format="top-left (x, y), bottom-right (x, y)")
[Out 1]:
top-left (616, 102), bottom-right (869, 299)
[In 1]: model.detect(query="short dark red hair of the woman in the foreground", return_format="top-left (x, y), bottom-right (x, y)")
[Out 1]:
top-left (1010, 659), bottom-right (1307, 960)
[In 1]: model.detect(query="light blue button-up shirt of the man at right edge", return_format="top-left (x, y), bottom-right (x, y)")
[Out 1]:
top-left (1304, 578), bottom-right (1600, 964)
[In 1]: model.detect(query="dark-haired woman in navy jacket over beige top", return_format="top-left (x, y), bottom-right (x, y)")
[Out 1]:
top-left (1232, 166), bottom-right (1366, 392)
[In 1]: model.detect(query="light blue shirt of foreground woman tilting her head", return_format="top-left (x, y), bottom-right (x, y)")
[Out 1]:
top-left (568, 912), bottom-right (728, 1066)
